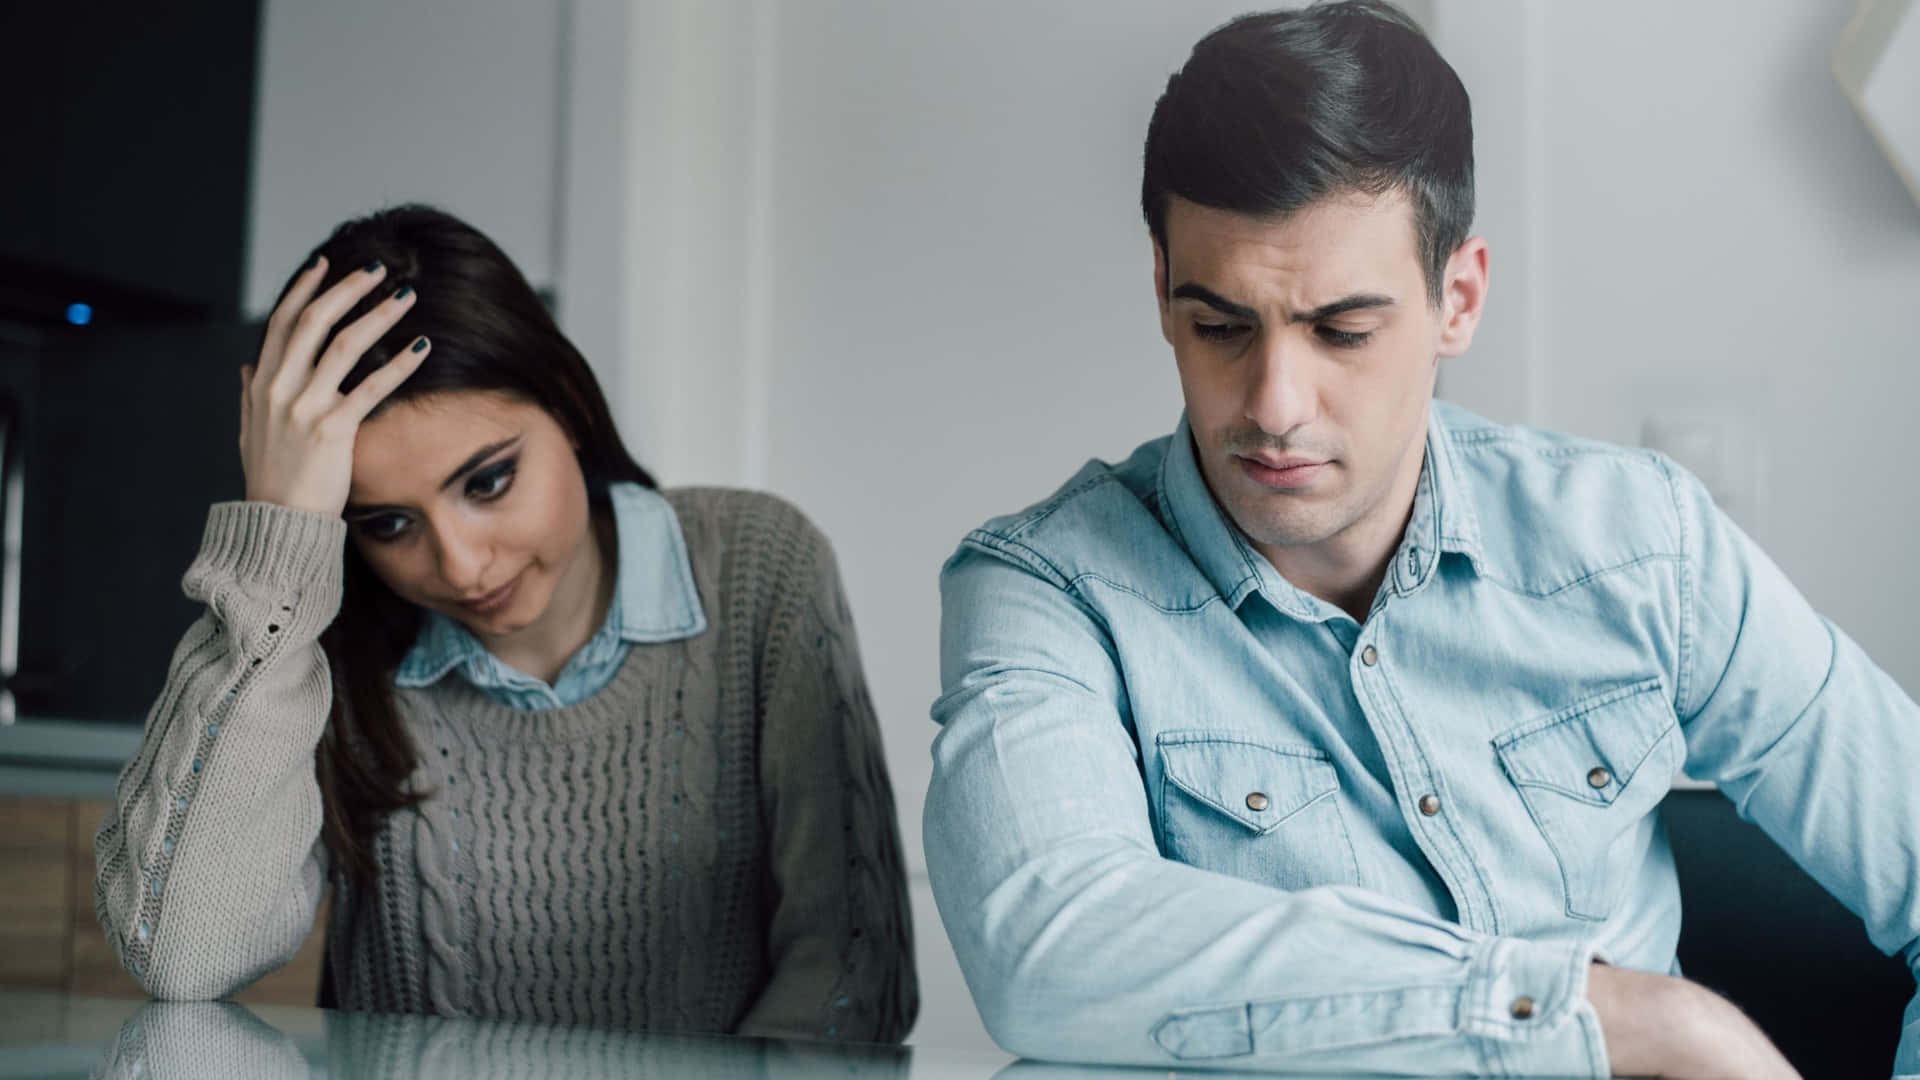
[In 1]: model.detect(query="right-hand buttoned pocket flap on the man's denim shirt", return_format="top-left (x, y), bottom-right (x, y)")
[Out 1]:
top-left (1494, 678), bottom-right (1678, 805)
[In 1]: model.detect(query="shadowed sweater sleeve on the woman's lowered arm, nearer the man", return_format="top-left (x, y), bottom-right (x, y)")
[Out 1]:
top-left (739, 521), bottom-right (920, 1042)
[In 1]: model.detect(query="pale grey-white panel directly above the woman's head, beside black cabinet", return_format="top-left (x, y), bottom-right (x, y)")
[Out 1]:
top-left (244, 0), bottom-right (566, 315)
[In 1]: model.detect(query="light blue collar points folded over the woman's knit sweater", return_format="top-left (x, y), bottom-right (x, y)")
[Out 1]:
top-left (394, 484), bottom-right (707, 688)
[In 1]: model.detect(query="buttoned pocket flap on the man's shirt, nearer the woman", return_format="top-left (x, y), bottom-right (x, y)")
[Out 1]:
top-left (1158, 732), bottom-right (1340, 834)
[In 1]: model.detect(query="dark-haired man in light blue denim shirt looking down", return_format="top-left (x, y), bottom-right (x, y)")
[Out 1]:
top-left (925, 2), bottom-right (1920, 1080)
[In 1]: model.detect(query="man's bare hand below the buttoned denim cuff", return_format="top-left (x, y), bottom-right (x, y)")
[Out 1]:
top-left (1586, 963), bottom-right (1801, 1080)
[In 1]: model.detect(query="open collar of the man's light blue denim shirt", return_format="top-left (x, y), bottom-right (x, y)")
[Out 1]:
top-left (1160, 402), bottom-right (1482, 621)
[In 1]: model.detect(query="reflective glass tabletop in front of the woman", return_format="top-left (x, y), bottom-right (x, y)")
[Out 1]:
top-left (0, 988), bottom-right (1512, 1080)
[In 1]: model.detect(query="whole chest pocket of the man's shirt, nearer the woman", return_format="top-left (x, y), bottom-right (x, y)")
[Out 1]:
top-left (1156, 730), bottom-right (1359, 890)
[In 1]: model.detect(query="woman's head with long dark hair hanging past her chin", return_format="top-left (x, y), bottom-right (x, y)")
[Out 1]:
top-left (282, 206), bottom-right (653, 886)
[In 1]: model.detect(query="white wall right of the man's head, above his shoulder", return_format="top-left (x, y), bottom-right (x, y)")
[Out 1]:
top-left (1436, 0), bottom-right (1920, 694)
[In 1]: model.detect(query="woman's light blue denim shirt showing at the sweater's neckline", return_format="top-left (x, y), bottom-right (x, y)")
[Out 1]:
top-left (394, 484), bottom-right (707, 709)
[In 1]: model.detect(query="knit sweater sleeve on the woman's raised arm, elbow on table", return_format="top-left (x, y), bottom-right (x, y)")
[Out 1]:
top-left (94, 502), bottom-right (346, 999)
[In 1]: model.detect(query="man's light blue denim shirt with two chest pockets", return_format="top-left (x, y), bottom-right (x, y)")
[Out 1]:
top-left (925, 402), bottom-right (1920, 1076)
